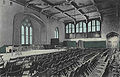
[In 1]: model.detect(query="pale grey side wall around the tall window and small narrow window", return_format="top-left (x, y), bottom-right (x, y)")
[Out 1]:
top-left (0, 0), bottom-right (64, 47)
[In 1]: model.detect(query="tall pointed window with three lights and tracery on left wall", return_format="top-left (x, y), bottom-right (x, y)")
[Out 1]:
top-left (21, 18), bottom-right (32, 44)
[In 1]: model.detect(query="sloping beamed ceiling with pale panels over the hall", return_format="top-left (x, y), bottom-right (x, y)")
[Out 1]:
top-left (11, 0), bottom-right (119, 22)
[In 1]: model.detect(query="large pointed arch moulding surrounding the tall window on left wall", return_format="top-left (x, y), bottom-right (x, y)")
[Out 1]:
top-left (12, 12), bottom-right (47, 45)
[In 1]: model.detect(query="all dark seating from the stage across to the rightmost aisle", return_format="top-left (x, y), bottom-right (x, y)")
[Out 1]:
top-left (0, 49), bottom-right (109, 77)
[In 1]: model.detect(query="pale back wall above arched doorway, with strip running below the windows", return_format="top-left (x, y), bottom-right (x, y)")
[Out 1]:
top-left (65, 14), bottom-right (120, 41)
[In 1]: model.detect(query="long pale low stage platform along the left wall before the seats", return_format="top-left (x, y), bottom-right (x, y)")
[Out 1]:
top-left (0, 49), bottom-right (66, 61)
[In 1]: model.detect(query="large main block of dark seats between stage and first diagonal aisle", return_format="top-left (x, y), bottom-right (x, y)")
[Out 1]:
top-left (0, 49), bottom-right (107, 77)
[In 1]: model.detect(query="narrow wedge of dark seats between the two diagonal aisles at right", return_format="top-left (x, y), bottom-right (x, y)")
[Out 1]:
top-left (70, 48), bottom-right (108, 77)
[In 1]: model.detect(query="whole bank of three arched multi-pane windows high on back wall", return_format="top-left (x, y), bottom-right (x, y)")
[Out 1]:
top-left (65, 19), bottom-right (101, 39)
